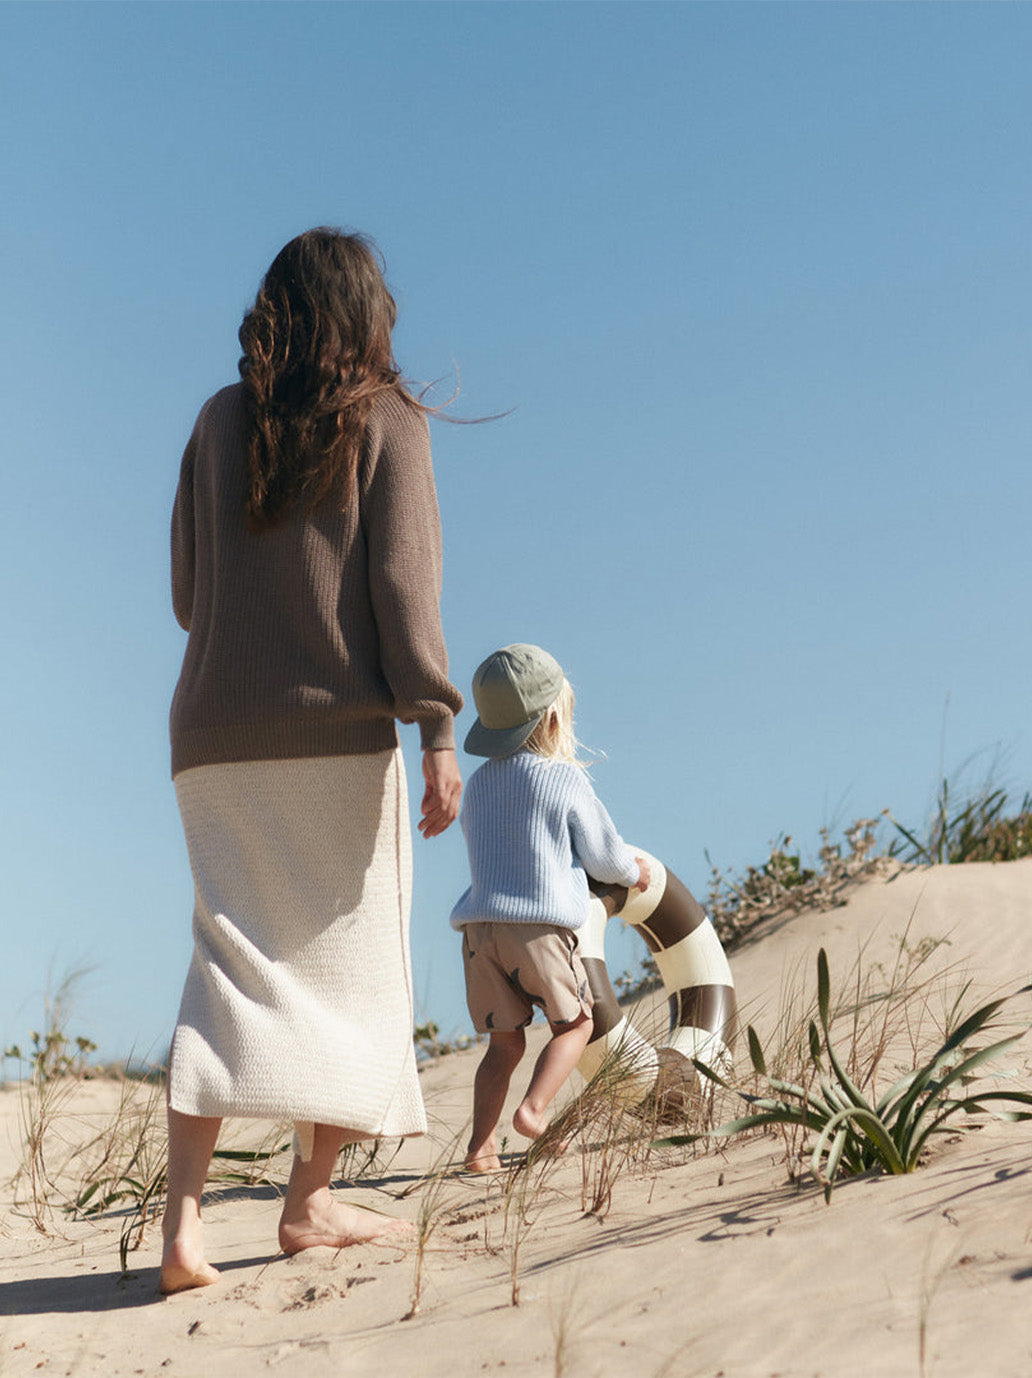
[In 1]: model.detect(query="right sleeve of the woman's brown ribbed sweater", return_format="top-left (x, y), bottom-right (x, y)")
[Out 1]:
top-left (361, 395), bottom-right (463, 751)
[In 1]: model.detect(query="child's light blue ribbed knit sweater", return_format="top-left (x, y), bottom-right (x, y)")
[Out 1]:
top-left (452, 751), bottom-right (638, 929)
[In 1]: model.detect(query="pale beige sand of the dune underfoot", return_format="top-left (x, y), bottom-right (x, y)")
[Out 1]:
top-left (0, 860), bottom-right (1032, 1378)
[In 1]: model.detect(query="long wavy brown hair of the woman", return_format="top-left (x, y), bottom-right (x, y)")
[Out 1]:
top-left (240, 227), bottom-right (416, 531)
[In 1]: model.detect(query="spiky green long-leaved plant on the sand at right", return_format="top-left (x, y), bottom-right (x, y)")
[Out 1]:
top-left (665, 948), bottom-right (1032, 1200)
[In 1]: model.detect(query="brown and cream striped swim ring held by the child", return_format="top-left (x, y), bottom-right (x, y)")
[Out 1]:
top-left (577, 847), bottom-right (736, 1116)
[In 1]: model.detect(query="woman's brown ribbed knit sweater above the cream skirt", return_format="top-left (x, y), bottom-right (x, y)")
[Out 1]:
top-left (169, 383), bottom-right (462, 774)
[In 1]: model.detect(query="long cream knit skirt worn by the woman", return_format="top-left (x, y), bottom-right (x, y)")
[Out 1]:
top-left (169, 751), bottom-right (426, 1158)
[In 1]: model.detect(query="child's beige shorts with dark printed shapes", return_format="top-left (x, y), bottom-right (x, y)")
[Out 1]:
top-left (462, 923), bottom-right (592, 1034)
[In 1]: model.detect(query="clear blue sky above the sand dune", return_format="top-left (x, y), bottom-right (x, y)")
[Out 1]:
top-left (0, 3), bottom-right (1032, 1057)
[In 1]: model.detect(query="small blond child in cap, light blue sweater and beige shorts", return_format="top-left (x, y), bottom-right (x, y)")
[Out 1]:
top-left (452, 645), bottom-right (649, 1173)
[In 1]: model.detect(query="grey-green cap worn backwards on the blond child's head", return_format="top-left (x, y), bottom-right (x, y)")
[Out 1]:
top-left (466, 642), bottom-right (565, 757)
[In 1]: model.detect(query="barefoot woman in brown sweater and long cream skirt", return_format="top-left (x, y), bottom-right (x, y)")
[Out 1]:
top-left (160, 229), bottom-right (462, 1293)
